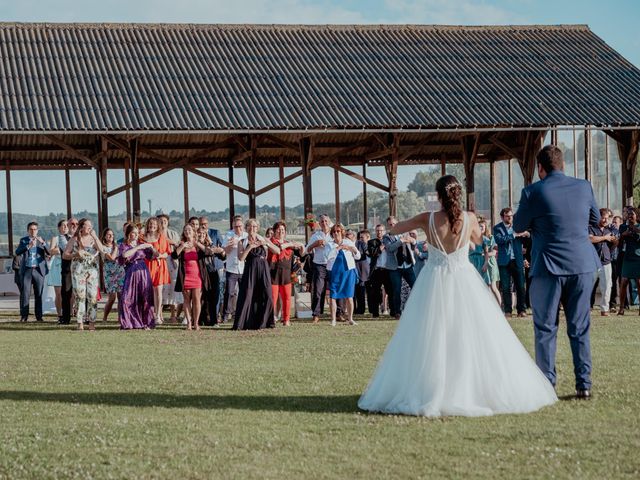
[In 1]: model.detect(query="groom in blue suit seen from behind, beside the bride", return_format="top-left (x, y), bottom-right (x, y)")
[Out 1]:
top-left (513, 145), bottom-right (600, 399)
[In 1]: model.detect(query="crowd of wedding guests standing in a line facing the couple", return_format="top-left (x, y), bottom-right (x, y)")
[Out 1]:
top-left (14, 201), bottom-right (640, 330)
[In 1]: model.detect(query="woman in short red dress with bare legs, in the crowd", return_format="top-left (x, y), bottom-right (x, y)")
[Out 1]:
top-left (172, 222), bottom-right (209, 330)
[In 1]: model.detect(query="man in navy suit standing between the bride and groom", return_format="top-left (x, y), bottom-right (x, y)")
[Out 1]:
top-left (493, 207), bottom-right (529, 317)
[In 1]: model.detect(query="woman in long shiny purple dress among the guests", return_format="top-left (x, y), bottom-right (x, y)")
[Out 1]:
top-left (118, 224), bottom-right (157, 330)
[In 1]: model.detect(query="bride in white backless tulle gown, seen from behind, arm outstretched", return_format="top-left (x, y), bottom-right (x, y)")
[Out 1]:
top-left (358, 175), bottom-right (557, 417)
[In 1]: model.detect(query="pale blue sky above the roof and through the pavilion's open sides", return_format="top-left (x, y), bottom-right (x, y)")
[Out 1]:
top-left (0, 0), bottom-right (640, 215)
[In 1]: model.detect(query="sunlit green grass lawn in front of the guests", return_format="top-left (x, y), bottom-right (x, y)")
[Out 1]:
top-left (0, 315), bottom-right (640, 480)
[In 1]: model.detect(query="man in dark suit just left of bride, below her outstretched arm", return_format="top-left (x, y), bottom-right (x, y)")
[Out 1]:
top-left (382, 216), bottom-right (416, 320)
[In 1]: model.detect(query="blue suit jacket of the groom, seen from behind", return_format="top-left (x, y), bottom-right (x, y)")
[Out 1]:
top-left (513, 171), bottom-right (600, 277)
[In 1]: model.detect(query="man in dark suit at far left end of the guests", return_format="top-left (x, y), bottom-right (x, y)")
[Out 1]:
top-left (16, 222), bottom-right (49, 322)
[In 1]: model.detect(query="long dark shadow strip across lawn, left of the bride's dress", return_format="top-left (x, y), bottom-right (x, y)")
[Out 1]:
top-left (0, 391), bottom-right (359, 413)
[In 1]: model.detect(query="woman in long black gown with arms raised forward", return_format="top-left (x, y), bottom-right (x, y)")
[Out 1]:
top-left (233, 218), bottom-right (280, 330)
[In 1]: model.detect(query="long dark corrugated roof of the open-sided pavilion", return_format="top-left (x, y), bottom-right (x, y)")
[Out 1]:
top-left (0, 23), bottom-right (640, 133)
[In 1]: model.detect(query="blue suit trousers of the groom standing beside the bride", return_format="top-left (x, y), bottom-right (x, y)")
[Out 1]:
top-left (531, 272), bottom-right (593, 390)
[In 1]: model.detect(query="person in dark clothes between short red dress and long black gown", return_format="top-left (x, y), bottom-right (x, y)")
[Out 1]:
top-left (198, 226), bottom-right (224, 326)
